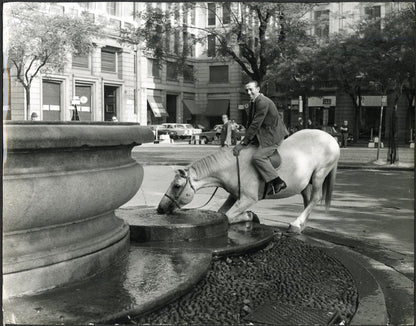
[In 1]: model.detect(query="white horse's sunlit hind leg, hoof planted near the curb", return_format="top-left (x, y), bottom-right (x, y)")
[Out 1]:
top-left (289, 170), bottom-right (325, 233)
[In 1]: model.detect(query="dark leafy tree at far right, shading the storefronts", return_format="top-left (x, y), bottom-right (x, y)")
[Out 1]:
top-left (304, 4), bottom-right (416, 141)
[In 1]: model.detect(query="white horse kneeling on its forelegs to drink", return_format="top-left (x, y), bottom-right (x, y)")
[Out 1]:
top-left (157, 129), bottom-right (340, 234)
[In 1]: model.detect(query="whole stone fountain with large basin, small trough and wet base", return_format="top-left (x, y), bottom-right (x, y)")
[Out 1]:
top-left (3, 121), bottom-right (273, 324)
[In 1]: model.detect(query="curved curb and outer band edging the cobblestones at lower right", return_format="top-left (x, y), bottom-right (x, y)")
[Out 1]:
top-left (279, 226), bottom-right (414, 325)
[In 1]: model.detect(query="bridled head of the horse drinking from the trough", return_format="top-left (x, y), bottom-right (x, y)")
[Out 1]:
top-left (157, 169), bottom-right (195, 214)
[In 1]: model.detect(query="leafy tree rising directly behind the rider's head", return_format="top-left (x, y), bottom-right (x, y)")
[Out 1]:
top-left (122, 2), bottom-right (313, 88)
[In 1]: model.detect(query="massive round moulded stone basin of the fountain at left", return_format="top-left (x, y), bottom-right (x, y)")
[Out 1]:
top-left (3, 121), bottom-right (153, 299)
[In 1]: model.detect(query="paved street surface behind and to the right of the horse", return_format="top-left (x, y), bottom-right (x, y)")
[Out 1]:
top-left (123, 143), bottom-right (414, 325)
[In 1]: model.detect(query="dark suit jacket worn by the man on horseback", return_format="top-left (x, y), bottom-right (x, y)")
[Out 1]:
top-left (241, 94), bottom-right (289, 147)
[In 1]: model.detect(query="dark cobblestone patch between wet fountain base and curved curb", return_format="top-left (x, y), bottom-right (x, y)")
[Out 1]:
top-left (132, 236), bottom-right (358, 325)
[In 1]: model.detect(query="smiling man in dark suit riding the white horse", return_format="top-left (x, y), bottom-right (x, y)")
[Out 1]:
top-left (233, 81), bottom-right (289, 195)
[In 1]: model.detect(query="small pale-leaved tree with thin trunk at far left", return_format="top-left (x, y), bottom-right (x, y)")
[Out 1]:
top-left (5, 2), bottom-right (100, 119)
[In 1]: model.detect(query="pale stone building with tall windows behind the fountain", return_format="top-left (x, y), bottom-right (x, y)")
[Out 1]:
top-left (3, 2), bottom-right (245, 127)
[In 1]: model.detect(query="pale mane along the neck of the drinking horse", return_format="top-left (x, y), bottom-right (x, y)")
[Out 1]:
top-left (188, 147), bottom-right (233, 180)
